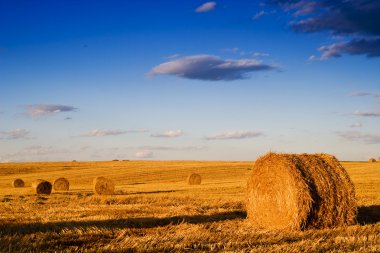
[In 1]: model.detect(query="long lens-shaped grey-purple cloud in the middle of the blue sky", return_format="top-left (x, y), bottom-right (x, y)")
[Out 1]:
top-left (149, 55), bottom-right (277, 81)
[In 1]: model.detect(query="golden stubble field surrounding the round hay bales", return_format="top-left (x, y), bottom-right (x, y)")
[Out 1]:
top-left (0, 161), bottom-right (380, 252)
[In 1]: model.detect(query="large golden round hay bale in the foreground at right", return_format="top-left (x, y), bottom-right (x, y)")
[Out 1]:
top-left (246, 153), bottom-right (357, 230)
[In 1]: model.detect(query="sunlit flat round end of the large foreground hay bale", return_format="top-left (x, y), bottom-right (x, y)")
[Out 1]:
top-left (246, 153), bottom-right (313, 230)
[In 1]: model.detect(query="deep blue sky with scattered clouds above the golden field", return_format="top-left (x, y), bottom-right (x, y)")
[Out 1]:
top-left (0, 0), bottom-right (380, 162)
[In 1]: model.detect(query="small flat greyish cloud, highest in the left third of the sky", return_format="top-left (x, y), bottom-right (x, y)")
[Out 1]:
top-left (25, 104), bottom-right (77, 118)
